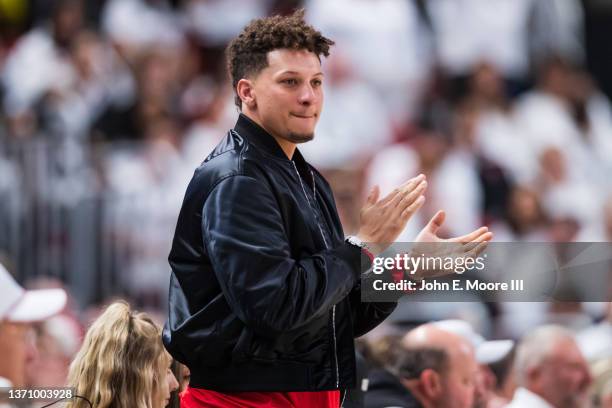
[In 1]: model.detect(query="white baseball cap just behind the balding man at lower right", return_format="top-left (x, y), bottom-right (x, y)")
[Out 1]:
top-left (432, 319), bottom-right (514, 364)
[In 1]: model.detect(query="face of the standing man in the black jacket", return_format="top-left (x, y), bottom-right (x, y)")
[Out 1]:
top-left (243, 49), bottom-right (323, 143)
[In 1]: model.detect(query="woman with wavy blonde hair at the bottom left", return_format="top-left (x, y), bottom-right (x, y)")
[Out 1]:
top-left (67, 302), bottom-right (178, 408)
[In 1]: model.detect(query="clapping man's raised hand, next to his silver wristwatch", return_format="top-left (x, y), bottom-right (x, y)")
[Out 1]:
top-left (357, 174), bottom-right (427, 256)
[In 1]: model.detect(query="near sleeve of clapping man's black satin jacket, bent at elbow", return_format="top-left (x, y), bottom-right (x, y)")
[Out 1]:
top-left (202, 175), bottom-right (360, 337)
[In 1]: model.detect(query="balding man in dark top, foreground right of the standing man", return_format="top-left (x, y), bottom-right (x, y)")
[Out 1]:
top-left (365, 324), bottom-right (478, 408)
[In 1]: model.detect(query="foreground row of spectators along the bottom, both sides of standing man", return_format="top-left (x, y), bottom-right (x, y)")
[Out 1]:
top-left (0, 260), bottom-right (612, 408)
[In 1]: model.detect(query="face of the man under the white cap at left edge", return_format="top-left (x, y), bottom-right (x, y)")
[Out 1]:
top-left (0, 322), bottom-right (36, 387)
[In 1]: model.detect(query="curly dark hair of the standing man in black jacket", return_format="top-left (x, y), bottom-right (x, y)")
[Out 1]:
top-left (226, 9), bottom-right (334, 109)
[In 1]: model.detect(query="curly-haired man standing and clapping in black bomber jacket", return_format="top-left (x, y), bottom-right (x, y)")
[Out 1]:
top-left (163, 7), bottom-right (492, 407)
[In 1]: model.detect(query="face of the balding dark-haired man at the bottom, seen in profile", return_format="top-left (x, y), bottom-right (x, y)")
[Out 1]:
top-left (436, 345), bottom-right (478, 408)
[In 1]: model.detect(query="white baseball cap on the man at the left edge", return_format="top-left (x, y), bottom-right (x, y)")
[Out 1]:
top-left (0, 264), bottom-right (67, 323)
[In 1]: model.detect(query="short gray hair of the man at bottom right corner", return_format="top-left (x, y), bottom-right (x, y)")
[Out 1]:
top-left (514, 325), bottom-right (574, 386)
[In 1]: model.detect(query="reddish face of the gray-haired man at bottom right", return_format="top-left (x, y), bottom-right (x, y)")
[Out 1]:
top-left (534, 339), bottom-right (591, 408)
